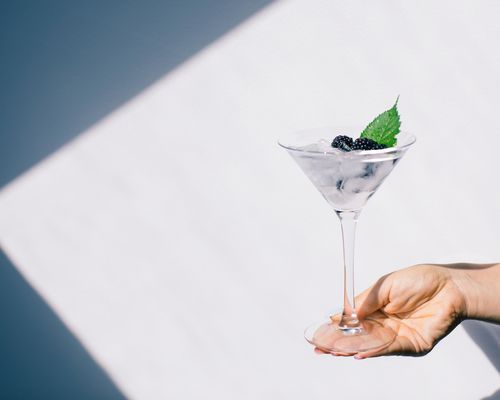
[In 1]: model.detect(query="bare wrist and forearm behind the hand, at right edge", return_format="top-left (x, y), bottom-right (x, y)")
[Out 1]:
top-left (454, 264), bottom-right (500, 323)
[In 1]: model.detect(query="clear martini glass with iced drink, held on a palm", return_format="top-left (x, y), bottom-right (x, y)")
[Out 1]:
top-left (278, 128), bottom-right (415, 355)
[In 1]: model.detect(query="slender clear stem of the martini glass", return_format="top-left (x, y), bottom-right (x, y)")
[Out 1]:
top-left (336, 211), bottom-right (361, 333)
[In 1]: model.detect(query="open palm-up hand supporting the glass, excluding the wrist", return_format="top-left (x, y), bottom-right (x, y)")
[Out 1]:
top-left (355, 265), bottom-right (467, 359)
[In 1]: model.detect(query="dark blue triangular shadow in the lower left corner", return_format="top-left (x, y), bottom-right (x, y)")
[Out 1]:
top-left (0, 251), bottom-right (126, 400)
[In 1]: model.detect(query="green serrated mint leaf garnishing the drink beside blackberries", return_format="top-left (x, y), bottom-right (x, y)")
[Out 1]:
top-left (360, 96), bottom-right (401, 147)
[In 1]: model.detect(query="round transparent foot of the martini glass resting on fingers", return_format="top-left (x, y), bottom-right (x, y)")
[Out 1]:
top-left (304, 315), bottom-right (396, 356)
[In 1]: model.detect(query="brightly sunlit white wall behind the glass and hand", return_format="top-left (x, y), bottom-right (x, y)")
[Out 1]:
top-left (0, 0), bottom-right (500, 399)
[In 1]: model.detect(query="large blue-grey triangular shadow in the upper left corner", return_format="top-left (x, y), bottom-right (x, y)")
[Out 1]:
top-left (0, 0), bottom-right (271, 188)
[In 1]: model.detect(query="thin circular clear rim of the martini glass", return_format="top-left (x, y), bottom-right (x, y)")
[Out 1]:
top-left (278, 127), bottom-right (417, 157)
